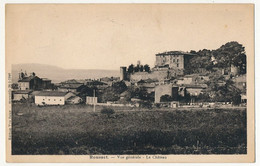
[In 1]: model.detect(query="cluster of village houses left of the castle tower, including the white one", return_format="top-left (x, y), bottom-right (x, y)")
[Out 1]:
top-left (12, 72), bottom-right (114, 105)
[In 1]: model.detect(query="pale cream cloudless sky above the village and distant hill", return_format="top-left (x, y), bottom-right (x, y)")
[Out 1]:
top-left (6, 4), bottom-right (253, 70)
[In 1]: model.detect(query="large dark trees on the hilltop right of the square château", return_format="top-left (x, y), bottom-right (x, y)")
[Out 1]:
top-left (186, 41), bottom-right (246, 74)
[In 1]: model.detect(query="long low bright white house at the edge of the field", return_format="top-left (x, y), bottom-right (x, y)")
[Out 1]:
top-left (35, 91), bottom-right (74, 105)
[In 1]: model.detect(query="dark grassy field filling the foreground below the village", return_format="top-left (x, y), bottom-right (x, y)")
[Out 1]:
top-left (12, 103), bottom-right (247, 155)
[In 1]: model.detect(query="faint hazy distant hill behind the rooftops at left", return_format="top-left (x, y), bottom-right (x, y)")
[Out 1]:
top-left (12, 63), bottom-right (119, 83)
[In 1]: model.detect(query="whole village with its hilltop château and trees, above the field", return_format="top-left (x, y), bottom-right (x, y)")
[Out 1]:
top-left (12, 42), bottom-right (247, 108)
